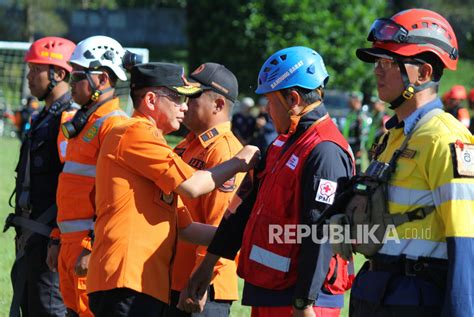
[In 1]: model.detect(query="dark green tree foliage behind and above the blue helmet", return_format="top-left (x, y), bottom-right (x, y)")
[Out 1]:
top-left (187, 0), bottom-right (386, 94)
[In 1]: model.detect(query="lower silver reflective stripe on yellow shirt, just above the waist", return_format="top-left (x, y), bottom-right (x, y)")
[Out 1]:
top-left (379, 239), bottom-right (448, 259)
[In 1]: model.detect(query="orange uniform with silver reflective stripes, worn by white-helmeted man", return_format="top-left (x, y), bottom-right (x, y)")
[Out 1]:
top-left (56, 98), bottom-right (128, 316)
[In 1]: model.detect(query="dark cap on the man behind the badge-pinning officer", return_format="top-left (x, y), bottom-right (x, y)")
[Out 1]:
top-left (189, 63), bottom-right (239, 102)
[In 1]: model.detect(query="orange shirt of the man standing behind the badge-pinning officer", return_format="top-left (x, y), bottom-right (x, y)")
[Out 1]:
top-left (171, 122), bottom-right (245, 300)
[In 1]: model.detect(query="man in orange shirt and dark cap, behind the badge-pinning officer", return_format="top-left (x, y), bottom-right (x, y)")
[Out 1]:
top-left (170, 63), bottom-right (244, 317)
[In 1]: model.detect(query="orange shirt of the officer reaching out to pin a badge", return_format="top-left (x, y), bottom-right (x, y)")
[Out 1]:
top-left (87, 112), bottom-right (194, 303)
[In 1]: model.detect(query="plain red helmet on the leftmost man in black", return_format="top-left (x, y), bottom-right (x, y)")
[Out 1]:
top-left (25, 36), bottom-right (76, 72)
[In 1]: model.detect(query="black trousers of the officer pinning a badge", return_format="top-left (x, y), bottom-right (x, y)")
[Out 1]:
top-left (89, 288), bottom-right (168, 317)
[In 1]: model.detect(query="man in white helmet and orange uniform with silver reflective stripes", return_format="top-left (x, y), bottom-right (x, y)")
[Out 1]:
top-left (49, 36), bottom-right (140, 316)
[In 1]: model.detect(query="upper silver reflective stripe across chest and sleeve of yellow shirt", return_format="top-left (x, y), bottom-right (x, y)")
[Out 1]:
top-left (388, 183), bottom-right (474, 206)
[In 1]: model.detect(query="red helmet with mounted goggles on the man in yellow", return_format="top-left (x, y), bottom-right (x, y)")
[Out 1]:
top-left (357, 9), bottom-right (459, 70)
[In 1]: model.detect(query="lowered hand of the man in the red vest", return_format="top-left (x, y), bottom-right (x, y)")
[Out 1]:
top-left (177, 253), bottom-right (219, 313)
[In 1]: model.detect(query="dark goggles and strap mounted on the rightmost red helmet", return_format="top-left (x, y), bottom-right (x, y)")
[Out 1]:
top-left (367, 18), bottom-right (458, 60)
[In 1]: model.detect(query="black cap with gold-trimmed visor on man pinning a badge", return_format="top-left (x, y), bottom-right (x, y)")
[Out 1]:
top-left (130, 63), bottom-right (202, 96)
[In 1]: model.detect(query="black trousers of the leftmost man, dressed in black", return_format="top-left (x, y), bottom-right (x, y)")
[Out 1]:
top-left (11, 235), bottom-right (66, 317)
